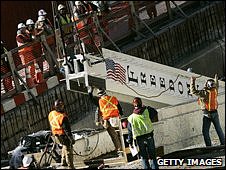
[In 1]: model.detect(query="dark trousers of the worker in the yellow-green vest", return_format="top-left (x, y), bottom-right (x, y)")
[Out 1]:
top-left (136, 133), bottom-right (159, 169)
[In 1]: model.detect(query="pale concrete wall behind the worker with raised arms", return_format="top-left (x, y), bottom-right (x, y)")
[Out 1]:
top-left (154, 93), bottom-right (225, 154)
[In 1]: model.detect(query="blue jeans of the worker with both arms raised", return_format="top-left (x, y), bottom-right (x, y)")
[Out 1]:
top-left (202, 110), bottom-right (225, 146)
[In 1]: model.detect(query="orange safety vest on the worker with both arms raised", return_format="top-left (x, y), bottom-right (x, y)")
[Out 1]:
top-left (205, 88), bottom-right (218, 111)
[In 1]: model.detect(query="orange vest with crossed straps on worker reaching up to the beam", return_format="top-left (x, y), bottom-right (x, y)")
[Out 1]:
top-left (99, 96), bottom-right (119, 120)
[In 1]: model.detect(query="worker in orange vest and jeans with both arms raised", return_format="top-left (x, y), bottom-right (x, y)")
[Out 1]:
top-left (190, 74), bottom-right (225, 146)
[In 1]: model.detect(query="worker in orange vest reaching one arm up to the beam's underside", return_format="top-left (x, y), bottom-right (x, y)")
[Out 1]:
top-left (88, 87), bottom-right (123, 156)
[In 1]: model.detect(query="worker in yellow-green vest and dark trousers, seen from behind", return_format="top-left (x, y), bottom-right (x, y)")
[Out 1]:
top-left (127, 97), bottom-right (158, 169)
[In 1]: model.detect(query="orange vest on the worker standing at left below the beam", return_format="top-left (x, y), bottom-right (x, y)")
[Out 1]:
top-left (48, 110), bottom-right (65, 135)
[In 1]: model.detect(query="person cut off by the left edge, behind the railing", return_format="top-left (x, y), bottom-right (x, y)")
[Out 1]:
top-left (1, 41), bottom-right (13, 92)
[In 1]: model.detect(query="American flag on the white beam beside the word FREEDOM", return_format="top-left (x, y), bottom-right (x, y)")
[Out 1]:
top-left (105, 58), bottom-right (126, 84)
